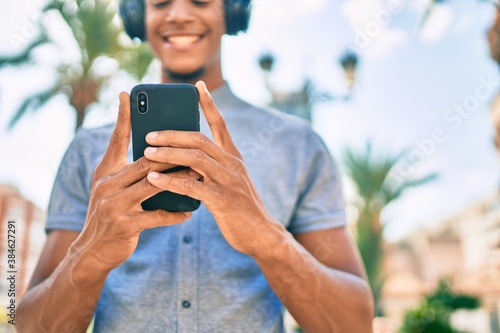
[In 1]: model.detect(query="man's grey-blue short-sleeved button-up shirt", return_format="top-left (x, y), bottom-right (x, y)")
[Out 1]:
top-left (46, 81), bottom-right (346, 333)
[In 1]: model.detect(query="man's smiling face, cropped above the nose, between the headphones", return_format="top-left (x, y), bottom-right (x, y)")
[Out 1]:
top-left (145, 0), bottom-right (225, 75)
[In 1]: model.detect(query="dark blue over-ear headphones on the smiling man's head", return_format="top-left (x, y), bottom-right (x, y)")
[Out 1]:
top-left (120, 0), bottom-right (251, 41)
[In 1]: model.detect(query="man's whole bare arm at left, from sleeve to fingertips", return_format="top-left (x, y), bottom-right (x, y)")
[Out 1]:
top-left (16, 93), bottom-right (193, 333)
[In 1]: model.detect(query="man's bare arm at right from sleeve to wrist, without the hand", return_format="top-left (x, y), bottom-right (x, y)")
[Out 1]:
top-left (254, 227), bottom-right (373, 333)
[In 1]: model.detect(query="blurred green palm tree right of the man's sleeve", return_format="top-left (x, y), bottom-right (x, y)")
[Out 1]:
top-left (343, 143), bottom-right (436, 314)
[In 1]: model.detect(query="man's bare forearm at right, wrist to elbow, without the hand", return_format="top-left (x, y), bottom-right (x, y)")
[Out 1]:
top-left (254, 224), bottom-right (373, 333)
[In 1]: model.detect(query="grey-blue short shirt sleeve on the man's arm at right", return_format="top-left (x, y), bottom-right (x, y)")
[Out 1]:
top-left (289, 130), bottom-right (347, 234)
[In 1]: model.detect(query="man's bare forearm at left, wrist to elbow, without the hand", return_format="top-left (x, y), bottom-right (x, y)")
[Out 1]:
top-left (16, 246), bottom-right (107, 333)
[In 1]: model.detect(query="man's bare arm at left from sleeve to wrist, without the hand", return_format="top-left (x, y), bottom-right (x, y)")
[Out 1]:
top-left (16, 230), bottom-right (107, 333)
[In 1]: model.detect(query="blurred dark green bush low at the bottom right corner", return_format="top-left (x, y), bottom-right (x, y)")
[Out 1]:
top-left (399, 281), bottom-right (480, 333)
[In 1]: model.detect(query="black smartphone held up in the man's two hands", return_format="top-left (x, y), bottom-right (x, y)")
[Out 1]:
top-left (130, 84), bottom-right (200, 212)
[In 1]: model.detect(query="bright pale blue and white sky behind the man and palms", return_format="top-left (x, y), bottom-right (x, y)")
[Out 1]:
top-left (0, 0), bottom-right (500, 240)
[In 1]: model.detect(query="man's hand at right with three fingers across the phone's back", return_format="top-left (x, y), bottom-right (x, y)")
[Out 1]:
top-left (144, 82), bottom-right (282, 255)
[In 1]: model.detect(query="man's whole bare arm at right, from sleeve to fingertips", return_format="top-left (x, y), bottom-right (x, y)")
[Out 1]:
top-left (145, 82), bottom-right (373, 333)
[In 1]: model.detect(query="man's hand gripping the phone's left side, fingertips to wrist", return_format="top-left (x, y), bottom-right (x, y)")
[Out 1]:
top-left (73, 93), bottom-right (194, 277)
